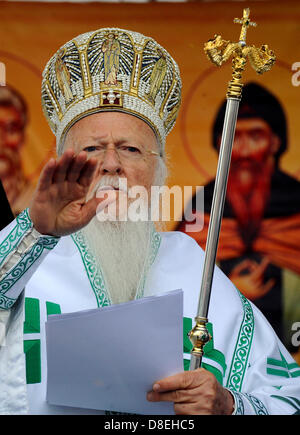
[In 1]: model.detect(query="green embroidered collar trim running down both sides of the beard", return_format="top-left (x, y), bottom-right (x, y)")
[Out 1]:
top-left (71, 230), bottom-right (161, 307)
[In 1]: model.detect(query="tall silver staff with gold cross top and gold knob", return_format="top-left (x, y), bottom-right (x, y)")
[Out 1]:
top-left (189, 8), bottom-right (275, 370)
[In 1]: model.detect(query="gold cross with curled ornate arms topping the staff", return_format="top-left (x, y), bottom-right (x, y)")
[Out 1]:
top-left (204, 8), bottom-right (276, 100)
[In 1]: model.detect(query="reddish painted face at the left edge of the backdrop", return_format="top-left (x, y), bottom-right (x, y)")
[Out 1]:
top-left (0, 106), bottom-right (24, 177)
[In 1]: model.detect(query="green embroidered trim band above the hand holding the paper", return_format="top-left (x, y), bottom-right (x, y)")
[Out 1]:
top-left (226, 291), bottom-right (254, 391)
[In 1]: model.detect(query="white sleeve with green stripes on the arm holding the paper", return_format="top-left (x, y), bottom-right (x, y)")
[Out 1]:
top-left (227, 301), bottom-right (300, 415)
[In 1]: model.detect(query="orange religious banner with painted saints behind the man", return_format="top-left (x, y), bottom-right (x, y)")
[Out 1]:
top-left (0, 1), bottom-right (300, 362)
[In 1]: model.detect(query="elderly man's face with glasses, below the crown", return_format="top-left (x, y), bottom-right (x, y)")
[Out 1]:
top-left (65, 112), bottom-right (158, 199)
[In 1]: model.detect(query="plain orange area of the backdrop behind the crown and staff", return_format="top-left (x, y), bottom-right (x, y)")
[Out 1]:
top-left (0, 2), bottom-right (300, 229)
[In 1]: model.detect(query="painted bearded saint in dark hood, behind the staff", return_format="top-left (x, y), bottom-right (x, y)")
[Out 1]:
top-left (177, 83), bottom-right (300, 352)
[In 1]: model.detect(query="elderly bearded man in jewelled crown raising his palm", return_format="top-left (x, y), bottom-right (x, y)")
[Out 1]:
top-left (0, 29), bottom-right (300, 414)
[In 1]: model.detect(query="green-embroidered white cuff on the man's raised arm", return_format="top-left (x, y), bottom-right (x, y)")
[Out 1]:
top-left (0, 209), bottom-right (60, 309)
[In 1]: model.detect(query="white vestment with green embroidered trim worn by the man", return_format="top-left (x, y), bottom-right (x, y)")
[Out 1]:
top-left (0, 210), bottom-right (300, 414)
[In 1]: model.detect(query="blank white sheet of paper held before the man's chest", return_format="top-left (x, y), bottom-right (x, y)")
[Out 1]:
top-left (46, 290), bottom-right (183, 415)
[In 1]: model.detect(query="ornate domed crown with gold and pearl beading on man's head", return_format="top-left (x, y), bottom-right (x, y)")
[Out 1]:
top-left (42, 28), bottom-right (181, 154)
